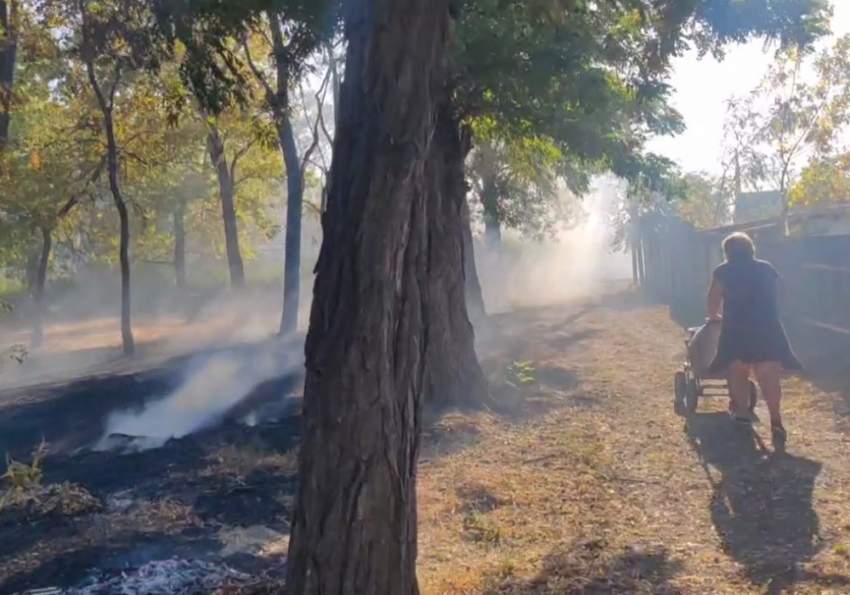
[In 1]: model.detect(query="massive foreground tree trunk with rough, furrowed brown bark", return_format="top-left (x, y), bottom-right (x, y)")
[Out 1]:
top-left (287, 0), bottom-right (449, 595)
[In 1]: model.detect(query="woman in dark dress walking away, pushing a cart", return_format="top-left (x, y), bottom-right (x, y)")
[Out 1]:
top-left (708, 233), bottom-right (802, 447)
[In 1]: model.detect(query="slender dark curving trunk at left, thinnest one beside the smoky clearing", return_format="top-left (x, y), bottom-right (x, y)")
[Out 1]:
top-left (103, 108), bottom-right (136, 355)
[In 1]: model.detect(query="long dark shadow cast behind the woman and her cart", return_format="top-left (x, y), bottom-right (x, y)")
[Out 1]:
top-left (685, 412), bottom-right (846, 594)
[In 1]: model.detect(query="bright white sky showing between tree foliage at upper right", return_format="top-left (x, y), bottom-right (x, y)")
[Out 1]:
top-left (649, 0), bottom-right (850, 174)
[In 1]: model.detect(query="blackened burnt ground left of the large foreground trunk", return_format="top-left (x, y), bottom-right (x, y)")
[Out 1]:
top-left (0, 343), bottom-right (302, 593)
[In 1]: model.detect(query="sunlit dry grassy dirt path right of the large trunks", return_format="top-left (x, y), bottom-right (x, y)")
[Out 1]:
top-left (420, 296), bottom-right (850, 595)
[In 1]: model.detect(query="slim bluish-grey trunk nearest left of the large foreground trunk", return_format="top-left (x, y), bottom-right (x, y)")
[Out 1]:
top-left (269, 13), bottom-right (304, 335)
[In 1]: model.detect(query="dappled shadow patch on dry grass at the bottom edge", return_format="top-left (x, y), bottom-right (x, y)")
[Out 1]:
top-left (484, 541), bottom-right (682, 595)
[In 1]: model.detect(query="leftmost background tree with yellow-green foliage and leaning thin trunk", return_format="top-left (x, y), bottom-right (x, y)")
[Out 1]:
top-left (0, 1), bottom-right (106, 347)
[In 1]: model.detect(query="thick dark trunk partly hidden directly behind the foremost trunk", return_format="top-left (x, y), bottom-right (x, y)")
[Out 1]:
top-left (427, 102), bottom-right (488, 409)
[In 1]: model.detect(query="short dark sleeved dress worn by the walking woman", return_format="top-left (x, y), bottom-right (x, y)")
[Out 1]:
top-left (709, 259), bottom-right (802, 374)
